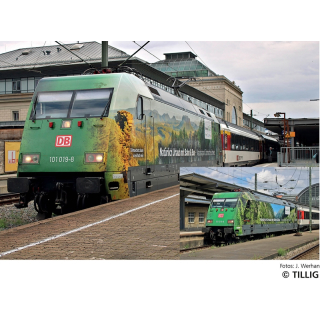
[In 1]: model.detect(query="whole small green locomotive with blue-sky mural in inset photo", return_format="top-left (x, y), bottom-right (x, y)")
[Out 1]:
top-left (203, 192), bottom-right (298, 242)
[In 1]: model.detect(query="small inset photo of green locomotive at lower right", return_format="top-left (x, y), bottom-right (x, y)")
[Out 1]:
top-left (180, 167), bottom-right (319, 260)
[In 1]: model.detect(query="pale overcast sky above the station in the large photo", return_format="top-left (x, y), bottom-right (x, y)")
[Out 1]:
top-left (0, 40), bottom-right (319, 120)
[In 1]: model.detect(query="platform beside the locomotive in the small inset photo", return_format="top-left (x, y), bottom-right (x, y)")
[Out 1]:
top-left (180, 230), bottom-right (319, 260)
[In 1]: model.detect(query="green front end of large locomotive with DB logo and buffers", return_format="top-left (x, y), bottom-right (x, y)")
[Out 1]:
top-left (8, 76), bottom-right (120, 219)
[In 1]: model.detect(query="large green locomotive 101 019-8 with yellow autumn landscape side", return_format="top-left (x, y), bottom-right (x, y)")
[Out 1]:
top-left (8, 72), bottom-right (222, 219)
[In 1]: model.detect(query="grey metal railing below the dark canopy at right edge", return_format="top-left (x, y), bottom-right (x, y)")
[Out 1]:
top-left (277, 147), bottom-right (319, 167)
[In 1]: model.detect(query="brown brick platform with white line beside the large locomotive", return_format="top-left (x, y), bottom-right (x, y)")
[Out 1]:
top-left (0, 186), bottom-right (179, 260)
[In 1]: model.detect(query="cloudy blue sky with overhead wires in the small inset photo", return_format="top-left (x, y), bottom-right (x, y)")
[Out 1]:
top-left (180, 167), bottom-right (319, 195)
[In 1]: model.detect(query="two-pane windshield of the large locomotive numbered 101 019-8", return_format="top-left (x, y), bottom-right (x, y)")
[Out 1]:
top-left (32, 89), bottom-right (112, 119)
